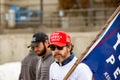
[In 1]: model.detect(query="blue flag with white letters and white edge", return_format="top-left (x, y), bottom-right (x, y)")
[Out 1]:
top-left (82, 13), bottom-right (120, 80)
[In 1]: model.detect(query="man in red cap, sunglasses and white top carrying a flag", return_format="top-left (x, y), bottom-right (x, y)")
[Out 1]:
top-left (49, 31), bottom-right (93, 80)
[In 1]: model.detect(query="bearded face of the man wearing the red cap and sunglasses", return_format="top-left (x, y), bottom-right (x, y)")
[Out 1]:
top-left (50, 45), bottom-right (70, 63)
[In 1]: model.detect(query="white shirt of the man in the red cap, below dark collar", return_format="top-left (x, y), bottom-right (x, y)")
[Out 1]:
top-left (49, 57), bottom-right (93, 80)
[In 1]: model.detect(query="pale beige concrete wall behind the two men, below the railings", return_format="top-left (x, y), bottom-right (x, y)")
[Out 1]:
top-left (0, 32), bottom-right (97, 63)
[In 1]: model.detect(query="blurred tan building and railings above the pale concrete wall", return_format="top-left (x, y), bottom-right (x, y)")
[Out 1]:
top-left (0, 0), bottom-right (119, 30)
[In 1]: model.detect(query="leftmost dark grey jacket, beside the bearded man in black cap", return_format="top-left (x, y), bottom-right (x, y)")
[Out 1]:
top-left (19, 50), bottom-right (38, 80)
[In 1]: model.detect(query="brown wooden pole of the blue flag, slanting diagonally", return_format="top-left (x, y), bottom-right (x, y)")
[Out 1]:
top-left (63, 6), bottom-right (120, 80)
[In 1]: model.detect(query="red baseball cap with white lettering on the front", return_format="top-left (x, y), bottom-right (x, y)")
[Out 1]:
top-left (50, 31), bottom-right (71, 47)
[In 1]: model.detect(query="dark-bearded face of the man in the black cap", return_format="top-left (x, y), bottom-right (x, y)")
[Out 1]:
top-left (34, 42), bottom-right (46, 56)
